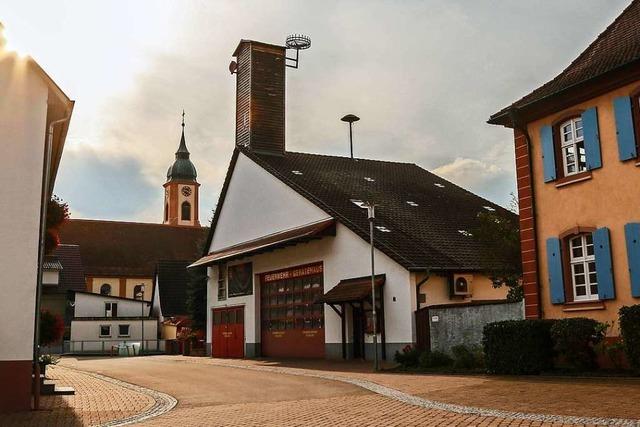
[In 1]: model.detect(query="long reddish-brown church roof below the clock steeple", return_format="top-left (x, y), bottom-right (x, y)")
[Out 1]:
top-left (60, 219), bottom-right (207, 277)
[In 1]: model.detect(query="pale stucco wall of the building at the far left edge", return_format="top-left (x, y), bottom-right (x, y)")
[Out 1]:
top-left (0, 52), bottom-right (48, 361)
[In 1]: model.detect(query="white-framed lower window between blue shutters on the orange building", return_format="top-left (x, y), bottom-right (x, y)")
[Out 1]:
top-left (569, 233), bottom-right (598, 301)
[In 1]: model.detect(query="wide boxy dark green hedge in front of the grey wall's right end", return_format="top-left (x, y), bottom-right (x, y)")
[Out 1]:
top-left (482, 319), bottom-right (554, 374)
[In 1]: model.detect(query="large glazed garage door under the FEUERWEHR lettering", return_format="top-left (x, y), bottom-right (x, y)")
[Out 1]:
top-left (261, 264), bottom-right (324, 357)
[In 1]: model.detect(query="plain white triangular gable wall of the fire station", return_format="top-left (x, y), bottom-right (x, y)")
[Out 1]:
top-left (209, 153), bottom-right (330, 252)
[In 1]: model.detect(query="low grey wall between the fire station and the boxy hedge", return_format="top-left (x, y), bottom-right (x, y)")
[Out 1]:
top-left (416, 301), bottom-right (524, 353)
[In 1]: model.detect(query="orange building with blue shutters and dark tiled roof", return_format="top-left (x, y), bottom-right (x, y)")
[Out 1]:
top-left (489, 0), bottom-right (640, 335)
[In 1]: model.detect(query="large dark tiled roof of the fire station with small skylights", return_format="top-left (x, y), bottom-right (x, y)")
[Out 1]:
top-left (218, 151), bottom-right (515, 271)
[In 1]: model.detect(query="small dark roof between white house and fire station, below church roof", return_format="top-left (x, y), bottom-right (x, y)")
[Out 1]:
top-left (157, 259), bottom-right (193, 317)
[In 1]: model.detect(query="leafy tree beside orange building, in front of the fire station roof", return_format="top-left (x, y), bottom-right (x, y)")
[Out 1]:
top-left (472, 194), bottom-right (524, 302)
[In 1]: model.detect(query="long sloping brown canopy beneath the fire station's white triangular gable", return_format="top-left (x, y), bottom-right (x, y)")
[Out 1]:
top-left (189, 218), bottom-right (336, 268)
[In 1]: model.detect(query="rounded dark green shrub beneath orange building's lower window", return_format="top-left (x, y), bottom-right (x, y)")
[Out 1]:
top-left (551, 317), bottom-right (607, 371)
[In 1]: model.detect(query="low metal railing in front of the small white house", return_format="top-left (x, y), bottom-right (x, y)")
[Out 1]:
top-left (63, 339), bottom-right (167, 356)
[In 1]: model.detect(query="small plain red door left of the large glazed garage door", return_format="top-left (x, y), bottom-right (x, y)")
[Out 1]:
top-left (211, 307), bottom-right (244, 357)
